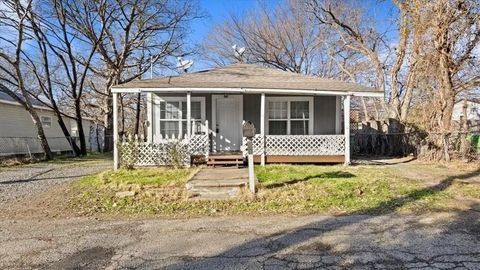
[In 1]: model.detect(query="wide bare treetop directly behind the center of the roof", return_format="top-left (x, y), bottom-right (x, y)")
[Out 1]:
top-left (203, 1), bottom-right (331, 76)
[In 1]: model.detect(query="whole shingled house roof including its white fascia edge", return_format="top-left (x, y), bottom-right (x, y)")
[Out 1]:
top-left (112, 64), bottom-right (383, 97)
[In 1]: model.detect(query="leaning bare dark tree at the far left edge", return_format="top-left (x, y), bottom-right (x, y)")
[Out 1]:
top-left (0, 0), bottom-right (53, 160)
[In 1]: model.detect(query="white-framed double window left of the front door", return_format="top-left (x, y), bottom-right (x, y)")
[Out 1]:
top-left (154, 97), bottom-right (205, 137)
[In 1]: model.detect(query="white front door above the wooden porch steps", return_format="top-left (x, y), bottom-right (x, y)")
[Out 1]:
top-left (213, 95), bottom-right (243, 152)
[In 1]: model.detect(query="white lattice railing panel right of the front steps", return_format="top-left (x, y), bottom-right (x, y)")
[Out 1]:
top-left (242, 134), bottom-right (345, 156)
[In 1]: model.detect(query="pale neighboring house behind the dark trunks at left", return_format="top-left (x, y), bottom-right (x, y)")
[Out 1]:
top-left (0, 92), bottom-right (102, 156)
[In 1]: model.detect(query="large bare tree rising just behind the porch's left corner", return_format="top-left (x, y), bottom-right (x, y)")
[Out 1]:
top-left (63, 0), bottom-right (198, 150)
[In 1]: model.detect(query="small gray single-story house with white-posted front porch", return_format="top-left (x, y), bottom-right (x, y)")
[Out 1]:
top-left (112, 64), bottom-right (384, 168)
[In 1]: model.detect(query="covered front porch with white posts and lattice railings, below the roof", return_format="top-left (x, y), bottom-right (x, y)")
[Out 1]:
top-left (114, 91), bottom-right (358, 167)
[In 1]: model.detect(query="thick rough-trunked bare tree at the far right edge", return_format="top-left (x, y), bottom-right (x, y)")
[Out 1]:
top-left (423, 0), bottom-right (480, 160)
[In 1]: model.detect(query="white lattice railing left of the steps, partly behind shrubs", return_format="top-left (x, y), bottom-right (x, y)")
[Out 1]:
top-left (120, 134), bottom-right (210, 166)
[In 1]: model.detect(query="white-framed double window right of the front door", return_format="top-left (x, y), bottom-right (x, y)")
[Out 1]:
top-left (267, 97), bottom-right (313, 135)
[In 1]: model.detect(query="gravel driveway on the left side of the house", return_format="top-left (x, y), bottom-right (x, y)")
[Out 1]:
top-left (0, 161), bottom-right (111, 205)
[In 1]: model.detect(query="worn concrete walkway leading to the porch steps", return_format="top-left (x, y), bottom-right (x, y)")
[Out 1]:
top-left (186, 167), bottom-right (248, 200)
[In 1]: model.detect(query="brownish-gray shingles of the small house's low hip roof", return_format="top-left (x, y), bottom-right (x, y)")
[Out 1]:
top-left (114, 64), bottom-right (381, 93)
